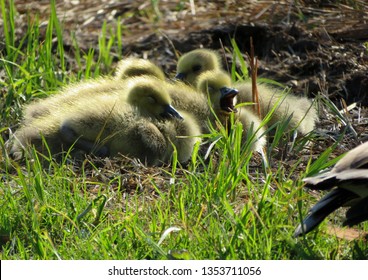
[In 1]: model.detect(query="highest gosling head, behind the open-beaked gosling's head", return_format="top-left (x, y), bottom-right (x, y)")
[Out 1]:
top-left (175, 49), bottom-right (222, 85)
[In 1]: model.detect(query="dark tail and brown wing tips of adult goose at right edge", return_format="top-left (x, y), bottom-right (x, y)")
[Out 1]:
top-left (294, 142), bottom-right (368, 237)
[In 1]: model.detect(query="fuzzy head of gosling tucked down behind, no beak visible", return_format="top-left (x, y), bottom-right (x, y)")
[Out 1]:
top-left (115, 57), bottom-right (165, 81)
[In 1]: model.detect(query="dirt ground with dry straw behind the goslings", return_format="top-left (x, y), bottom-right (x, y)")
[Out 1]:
top-left (0, 0), bottom-right (368, 164)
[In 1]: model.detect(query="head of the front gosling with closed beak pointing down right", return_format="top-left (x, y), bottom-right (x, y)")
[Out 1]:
top-left (127, 76), bottom-right (183, 120)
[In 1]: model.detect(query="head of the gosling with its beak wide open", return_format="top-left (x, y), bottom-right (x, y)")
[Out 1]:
top-left (196, 70), bottom-right (238, 114)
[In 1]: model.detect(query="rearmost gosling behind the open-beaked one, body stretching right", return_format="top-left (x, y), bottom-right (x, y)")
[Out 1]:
top-left (176, 49), bottom-right (318, 135)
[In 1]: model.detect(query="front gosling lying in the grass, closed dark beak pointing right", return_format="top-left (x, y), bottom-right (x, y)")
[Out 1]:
top-left (10, 77), bottom-right (200, 165)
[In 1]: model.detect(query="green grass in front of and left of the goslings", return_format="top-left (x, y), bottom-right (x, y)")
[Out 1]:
top-left (0, 0), bottom-right (368, 260)
